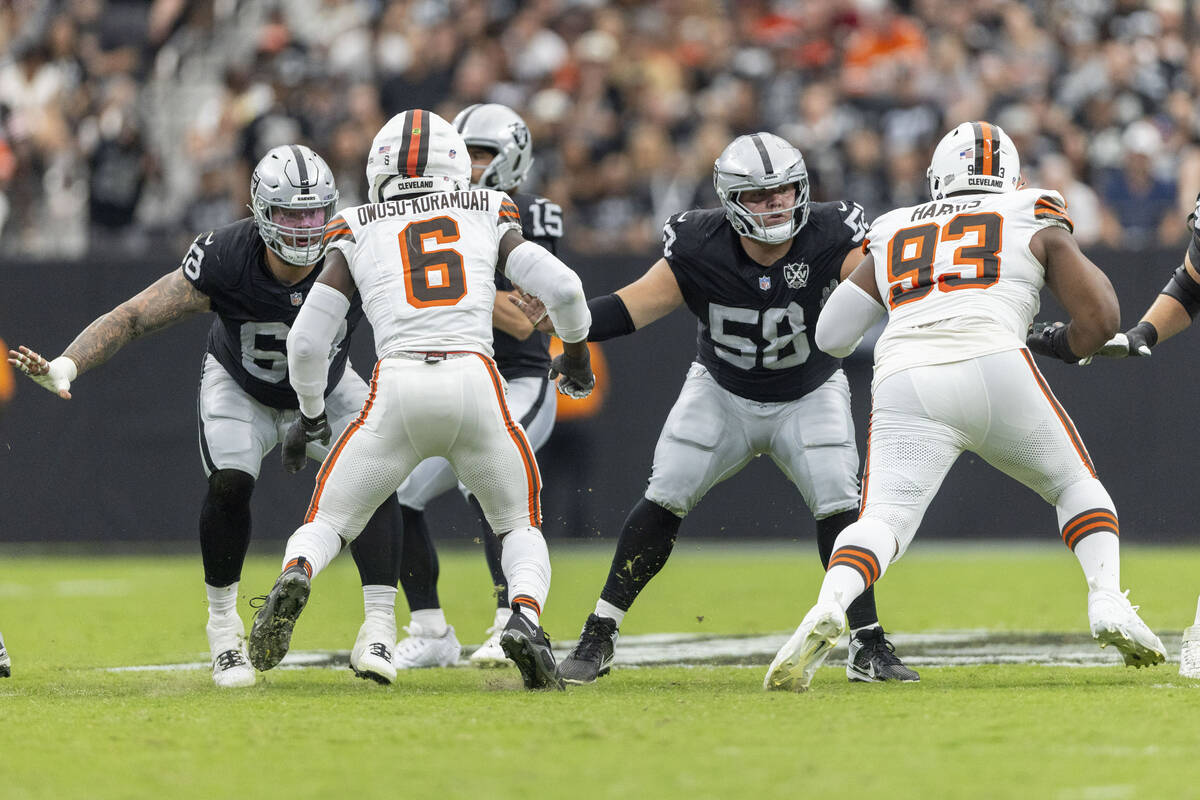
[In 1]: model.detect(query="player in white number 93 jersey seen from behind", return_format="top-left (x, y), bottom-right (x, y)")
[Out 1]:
top-left (763, 122), bottom-right (1165, 691)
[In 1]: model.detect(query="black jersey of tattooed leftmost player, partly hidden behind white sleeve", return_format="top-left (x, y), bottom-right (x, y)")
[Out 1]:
top-left (182, 217), bottom-right (362, 409)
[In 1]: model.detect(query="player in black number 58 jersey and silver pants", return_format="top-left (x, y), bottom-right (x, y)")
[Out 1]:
top-left (522, 133), bottom-right (918, 684)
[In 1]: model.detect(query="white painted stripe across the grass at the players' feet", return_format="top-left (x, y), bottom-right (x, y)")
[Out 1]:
top-left (104, 631), bottom-right (1180, 672)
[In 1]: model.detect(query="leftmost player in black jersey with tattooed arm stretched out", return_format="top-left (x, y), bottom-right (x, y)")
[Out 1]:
top-left (8, 145), bottom-right (398, 687)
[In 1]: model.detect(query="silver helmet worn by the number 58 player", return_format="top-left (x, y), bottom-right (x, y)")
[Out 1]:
top-left (713, 132), bottom-right (809, 245)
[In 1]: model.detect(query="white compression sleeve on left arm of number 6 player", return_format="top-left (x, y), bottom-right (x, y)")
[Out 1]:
top-left (288, 282), bottom-right (350, 417)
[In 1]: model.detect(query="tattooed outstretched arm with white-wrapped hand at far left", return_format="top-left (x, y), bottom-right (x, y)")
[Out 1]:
top-left (8, 269), bottom-right (210, 399)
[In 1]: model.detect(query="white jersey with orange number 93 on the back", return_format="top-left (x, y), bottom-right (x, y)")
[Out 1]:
top-left (864, 188), bottom-right (1072, 385)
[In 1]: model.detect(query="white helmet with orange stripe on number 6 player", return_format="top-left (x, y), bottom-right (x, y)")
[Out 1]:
top-left (367, 108), bottom-right (470, 203)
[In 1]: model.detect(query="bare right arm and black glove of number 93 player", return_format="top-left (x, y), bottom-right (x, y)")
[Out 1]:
top-left (1030, 227), bottom-right (1121, 363)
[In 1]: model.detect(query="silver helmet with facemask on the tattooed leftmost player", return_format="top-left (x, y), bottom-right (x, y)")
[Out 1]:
top-left (250, 144), bottom-right (337, 266)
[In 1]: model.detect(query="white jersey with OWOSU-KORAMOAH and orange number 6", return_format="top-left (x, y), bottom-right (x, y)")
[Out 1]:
top-left (325, 190), bottom-right (521, 359)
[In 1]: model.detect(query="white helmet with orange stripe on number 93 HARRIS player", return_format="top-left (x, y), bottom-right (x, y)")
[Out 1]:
top-left (925, 122), bottom-right (1021, 200)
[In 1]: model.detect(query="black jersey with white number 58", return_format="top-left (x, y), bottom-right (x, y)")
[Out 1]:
top-left (662, 201), bottom-right (866, 403)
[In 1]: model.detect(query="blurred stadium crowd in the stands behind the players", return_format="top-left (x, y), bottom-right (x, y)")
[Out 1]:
top-left (0, 0), bottom-right (1200, 258)
